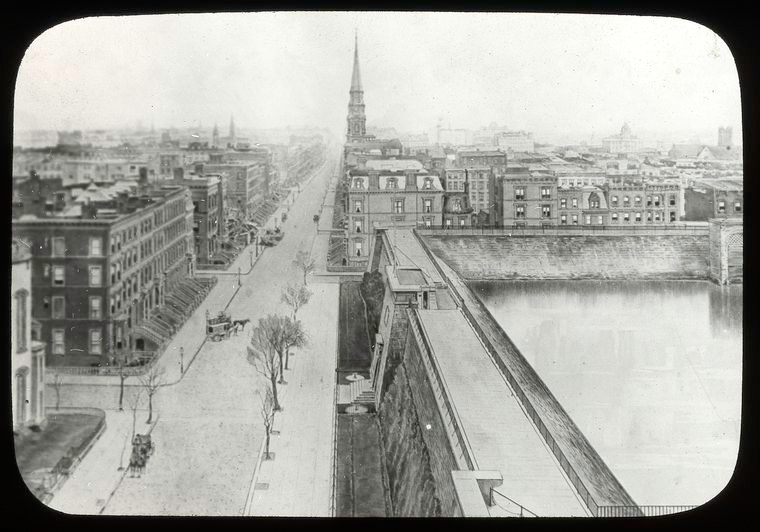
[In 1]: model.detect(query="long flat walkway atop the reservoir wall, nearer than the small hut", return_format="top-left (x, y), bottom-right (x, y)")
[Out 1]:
top-left (418, 310), bottom-right (589, 517)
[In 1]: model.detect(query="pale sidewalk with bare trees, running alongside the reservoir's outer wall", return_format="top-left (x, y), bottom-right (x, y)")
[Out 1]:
top-left (245, 283), bottom-right (339, 517)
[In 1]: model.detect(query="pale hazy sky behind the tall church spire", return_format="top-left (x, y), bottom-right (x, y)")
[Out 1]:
top-left (15, 12), bottom-right (741, 143)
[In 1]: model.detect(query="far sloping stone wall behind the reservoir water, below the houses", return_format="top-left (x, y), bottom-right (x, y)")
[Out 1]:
top-left (422, 235), bottom-right (710, 280)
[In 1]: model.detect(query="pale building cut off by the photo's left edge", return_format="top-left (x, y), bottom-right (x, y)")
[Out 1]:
top-left (9, 239), bottom-right (45, 432)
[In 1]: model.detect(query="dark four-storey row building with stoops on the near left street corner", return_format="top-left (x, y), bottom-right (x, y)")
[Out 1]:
top-left (13, 186), bottom-right (194, 366)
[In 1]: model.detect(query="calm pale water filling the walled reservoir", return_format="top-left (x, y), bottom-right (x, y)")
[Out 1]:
top-left (470, 281), bottom-right (742, 505)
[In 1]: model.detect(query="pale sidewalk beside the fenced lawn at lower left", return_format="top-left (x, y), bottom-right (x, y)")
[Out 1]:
top-left (49, 409), bottom-right (156, 515)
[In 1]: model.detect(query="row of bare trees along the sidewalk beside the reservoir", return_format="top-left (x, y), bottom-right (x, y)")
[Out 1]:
top-left (247, 280), bottom-right (312, 458)
